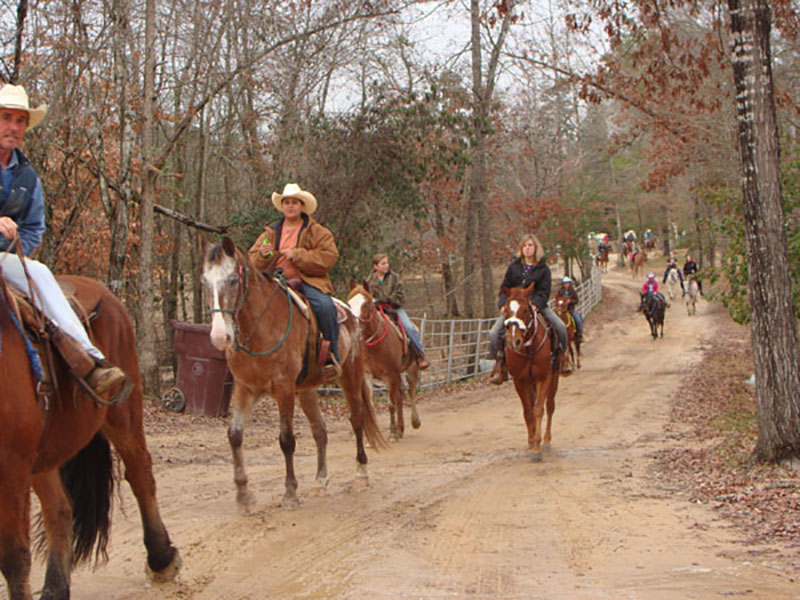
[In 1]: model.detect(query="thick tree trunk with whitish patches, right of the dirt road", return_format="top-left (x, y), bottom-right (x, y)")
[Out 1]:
top-left (728, 0), bottom-right (800, 462)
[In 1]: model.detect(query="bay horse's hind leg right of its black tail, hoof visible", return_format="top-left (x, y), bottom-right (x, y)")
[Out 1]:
top-left (103, 414), bottom-right (181, 583)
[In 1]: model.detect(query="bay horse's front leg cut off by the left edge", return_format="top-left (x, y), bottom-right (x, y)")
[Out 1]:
top-left (0, 468), bottom-right (32, 600)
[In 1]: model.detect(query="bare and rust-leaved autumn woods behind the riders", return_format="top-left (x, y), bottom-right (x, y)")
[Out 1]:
top-left (0, 0), bottom-right (800, 424)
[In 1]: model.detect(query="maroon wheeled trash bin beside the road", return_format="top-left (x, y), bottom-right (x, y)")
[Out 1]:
top-left (163, 321), bottom-right (233, 417)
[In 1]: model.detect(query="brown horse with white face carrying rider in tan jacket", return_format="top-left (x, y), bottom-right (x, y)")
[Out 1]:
top-left (202, 237), bottom-right (386, 511)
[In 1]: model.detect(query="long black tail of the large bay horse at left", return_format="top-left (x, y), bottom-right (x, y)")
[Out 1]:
top-left (61, 433), bottom-right (114, 564)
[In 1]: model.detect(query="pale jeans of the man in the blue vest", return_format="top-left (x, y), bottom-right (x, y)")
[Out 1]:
top-left (0, 252), bottom-right (105, 360)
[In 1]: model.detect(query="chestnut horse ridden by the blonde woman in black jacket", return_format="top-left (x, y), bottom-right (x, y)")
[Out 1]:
top-left (501, 283), bottom-right (558, 461)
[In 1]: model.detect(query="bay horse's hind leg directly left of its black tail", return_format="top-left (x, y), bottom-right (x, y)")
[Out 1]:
top-left (31, 469), bottom-right (72, 600)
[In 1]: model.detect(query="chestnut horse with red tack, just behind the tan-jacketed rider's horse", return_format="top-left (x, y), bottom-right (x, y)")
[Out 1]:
top-left (347, 282), bottom-right (421, 440)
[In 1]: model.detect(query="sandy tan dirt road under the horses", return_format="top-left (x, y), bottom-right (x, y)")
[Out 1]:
top-left (18, 270), bottom-right (800, 600)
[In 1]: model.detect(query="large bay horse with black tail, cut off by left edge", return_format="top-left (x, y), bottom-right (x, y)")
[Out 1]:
top-left (0, 277), bottom-right (180, 600)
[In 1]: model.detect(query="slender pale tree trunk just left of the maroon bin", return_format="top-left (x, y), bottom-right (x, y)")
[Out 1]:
top-left (136, 0), bottom-right (160, 398)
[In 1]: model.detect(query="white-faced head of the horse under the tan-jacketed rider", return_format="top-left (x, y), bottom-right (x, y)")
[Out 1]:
top-left (201, 237), bottom-right (250, 350)
